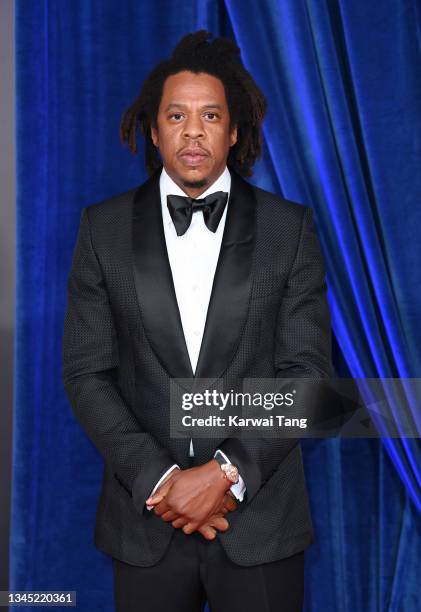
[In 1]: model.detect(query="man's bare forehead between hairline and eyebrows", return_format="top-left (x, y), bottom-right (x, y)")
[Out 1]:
top-left (161, 70), bottom-right (226, 106)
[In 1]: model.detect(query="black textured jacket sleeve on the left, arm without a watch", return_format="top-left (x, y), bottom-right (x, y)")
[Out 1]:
top-left (62, 208), bottom-right (175, 513)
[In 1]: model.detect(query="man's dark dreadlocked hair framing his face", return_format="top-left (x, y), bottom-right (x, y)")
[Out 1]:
top-left (120, 30), bottom-right (267, 177)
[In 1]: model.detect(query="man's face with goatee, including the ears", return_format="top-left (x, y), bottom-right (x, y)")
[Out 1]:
top-left (151, 70), bottom-right (237, 197)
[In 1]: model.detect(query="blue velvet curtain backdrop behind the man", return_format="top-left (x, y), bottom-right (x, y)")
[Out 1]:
top-left (10, 0), bottom-right (421, 612)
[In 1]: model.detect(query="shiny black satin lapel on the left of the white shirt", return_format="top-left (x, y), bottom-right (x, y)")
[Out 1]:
top-left (132, 171), bottom-right (193, 378)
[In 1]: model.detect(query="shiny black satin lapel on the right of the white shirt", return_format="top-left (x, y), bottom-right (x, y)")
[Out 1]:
top-left (195, 170), bottom-right (256, 378)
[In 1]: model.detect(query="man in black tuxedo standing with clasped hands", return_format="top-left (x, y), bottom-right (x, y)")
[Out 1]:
top-left (63, 30), bottom-right (331, 612)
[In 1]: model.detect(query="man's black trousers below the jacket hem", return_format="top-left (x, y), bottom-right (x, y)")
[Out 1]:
top-left (112, 529), bottom-right (304, 612)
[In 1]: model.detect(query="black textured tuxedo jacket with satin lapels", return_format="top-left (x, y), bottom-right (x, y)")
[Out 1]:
top-left (63, 169), bottom-right (332, 566)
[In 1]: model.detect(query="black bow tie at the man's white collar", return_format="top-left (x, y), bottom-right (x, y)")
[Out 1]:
top-left (167, 191), bottom-right (228, 236)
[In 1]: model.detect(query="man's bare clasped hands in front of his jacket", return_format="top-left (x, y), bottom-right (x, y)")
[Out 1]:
top-left (146, 459), bottom-right (237, 540)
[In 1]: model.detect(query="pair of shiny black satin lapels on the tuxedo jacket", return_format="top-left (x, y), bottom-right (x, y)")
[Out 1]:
top-left (132, 169), bottom-right (256, 378)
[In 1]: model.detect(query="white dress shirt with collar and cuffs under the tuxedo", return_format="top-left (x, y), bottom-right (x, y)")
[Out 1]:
top-left (146, 166), bottom-right (246, 510)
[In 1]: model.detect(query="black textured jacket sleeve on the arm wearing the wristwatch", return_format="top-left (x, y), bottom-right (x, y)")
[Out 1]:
top-left (219, 207), bottom-right (333, 503)
